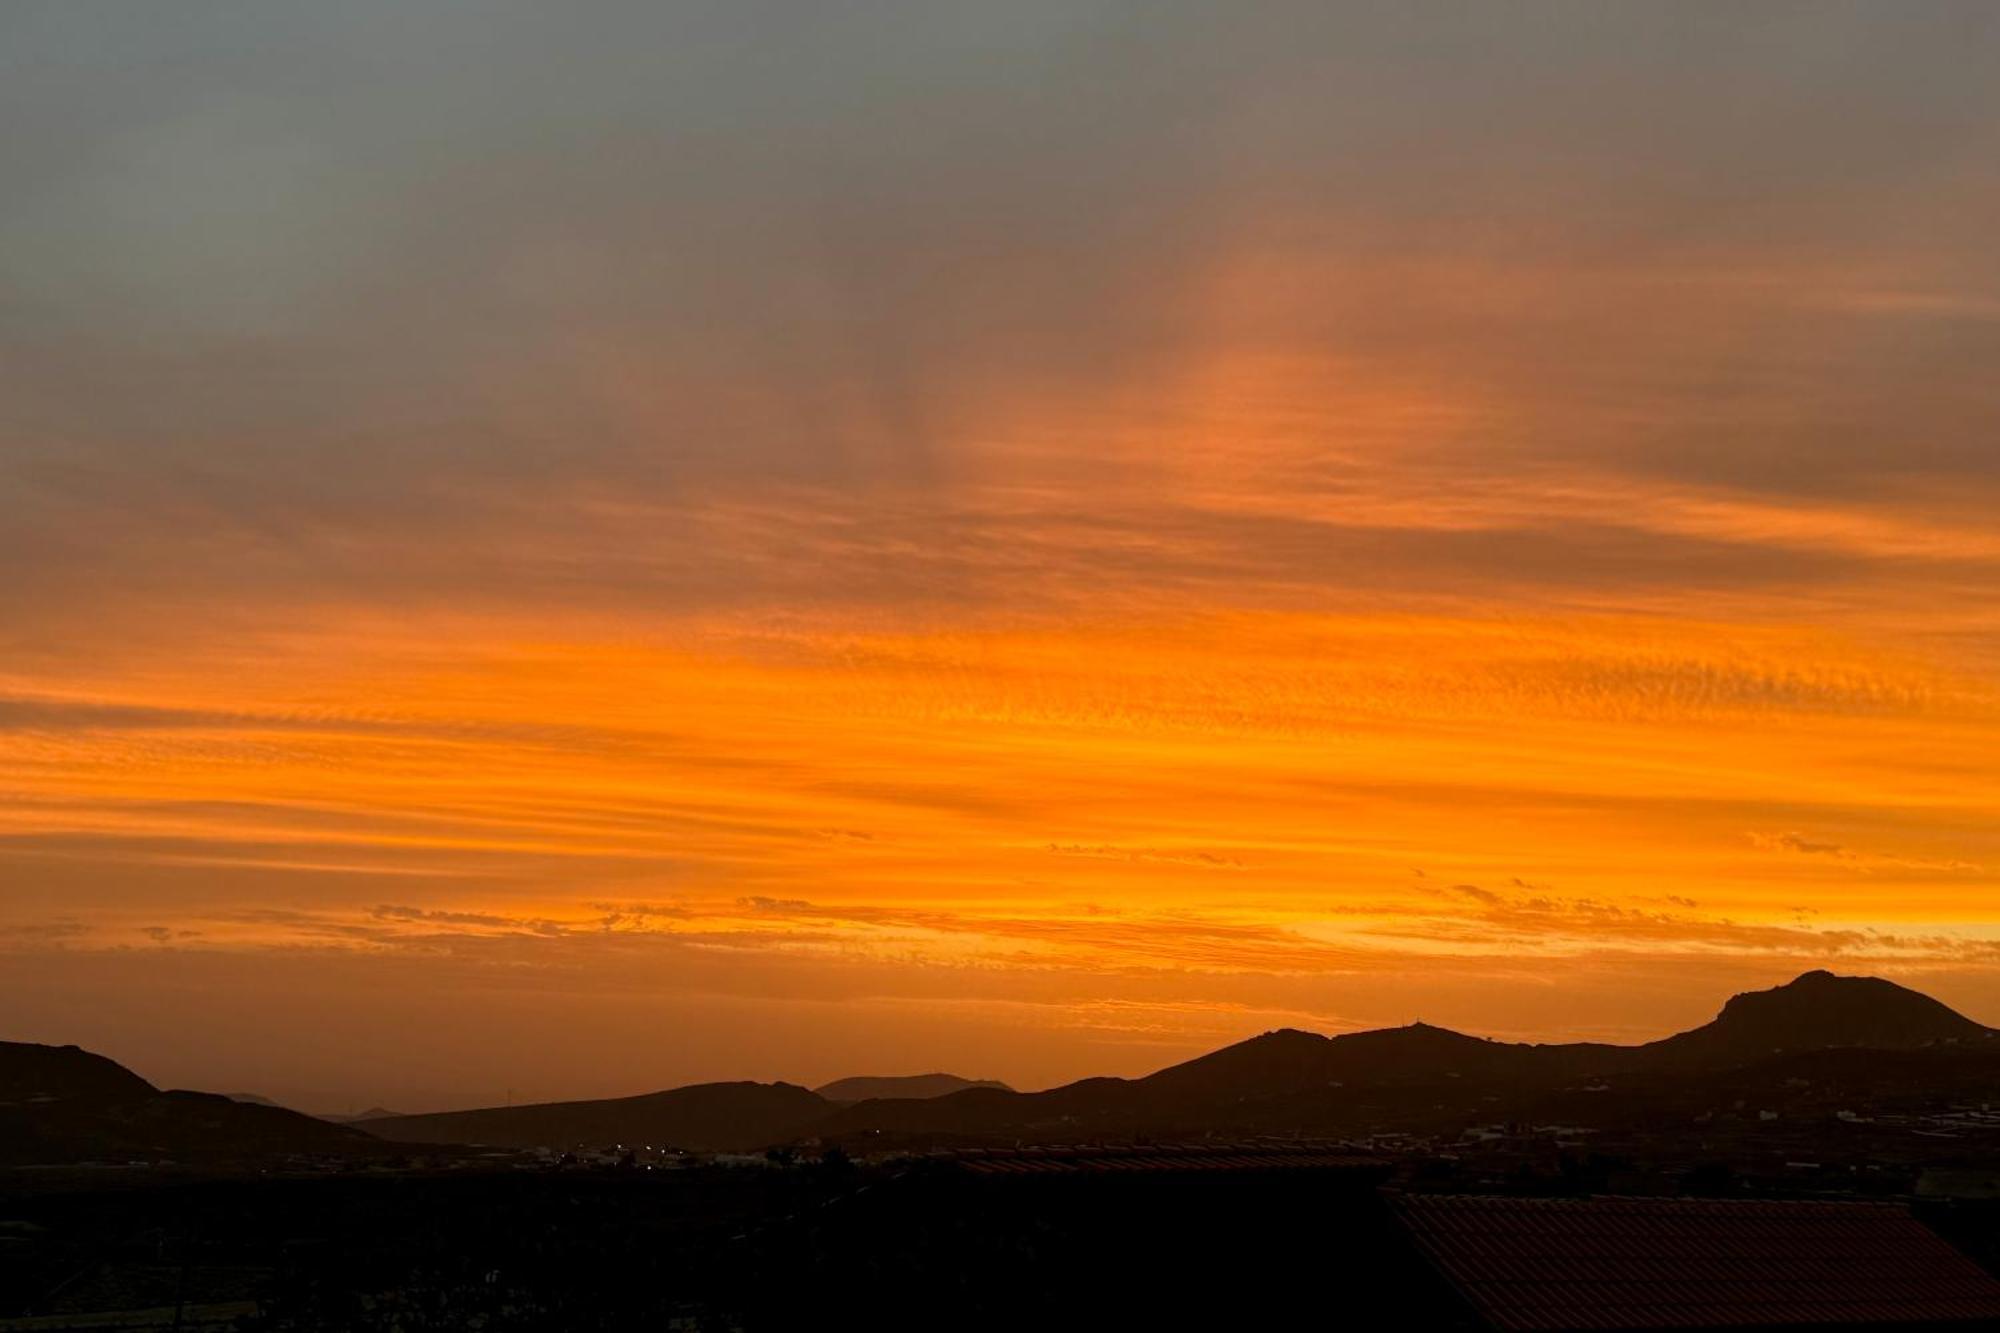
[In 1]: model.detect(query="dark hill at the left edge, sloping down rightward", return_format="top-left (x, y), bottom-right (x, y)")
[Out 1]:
top-left (0, 1041), bottom-right (380, 1165)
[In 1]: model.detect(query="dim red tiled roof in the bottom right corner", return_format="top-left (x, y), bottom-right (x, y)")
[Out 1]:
top-left (1394, 1195), bottom-right (2000, 1329)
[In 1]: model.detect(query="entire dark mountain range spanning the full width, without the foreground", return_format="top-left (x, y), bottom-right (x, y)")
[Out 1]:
top-left (0, 971), bottom-right (2000, 1163)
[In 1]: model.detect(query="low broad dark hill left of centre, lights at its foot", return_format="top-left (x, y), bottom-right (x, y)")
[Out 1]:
top-left (360, 1083), bottom-right (834, 1151)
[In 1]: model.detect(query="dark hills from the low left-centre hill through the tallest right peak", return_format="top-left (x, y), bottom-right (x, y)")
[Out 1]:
top-left (352, 973), bottom-right (2000, 1149)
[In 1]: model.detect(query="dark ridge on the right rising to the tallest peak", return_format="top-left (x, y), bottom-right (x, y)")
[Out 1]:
top-left (818, 973), bottom-right (2000, 1141)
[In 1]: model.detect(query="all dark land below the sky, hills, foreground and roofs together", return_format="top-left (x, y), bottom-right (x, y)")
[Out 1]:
top-left (11, 973), bottom-right (2000, 1329)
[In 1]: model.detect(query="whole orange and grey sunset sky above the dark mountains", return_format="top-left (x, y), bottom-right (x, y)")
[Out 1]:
top-left (0, 0), bottom-right (2000, 1111)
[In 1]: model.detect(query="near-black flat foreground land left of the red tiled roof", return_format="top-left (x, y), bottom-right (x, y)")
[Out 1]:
top-left (4, 1163), bottom-right (1440, 1329)
